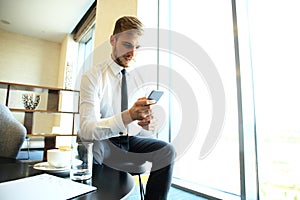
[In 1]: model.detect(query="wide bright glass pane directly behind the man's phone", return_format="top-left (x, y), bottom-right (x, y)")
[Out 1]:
top-left (139, 0), bottom-right (240, 199)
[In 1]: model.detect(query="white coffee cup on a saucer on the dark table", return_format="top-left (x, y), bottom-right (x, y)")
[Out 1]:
top-left (47, 149), bottom-right (71, 167)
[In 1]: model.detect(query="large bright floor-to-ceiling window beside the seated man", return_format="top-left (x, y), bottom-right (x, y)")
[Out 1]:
top-left (138, 0), bottom-right (300, 199)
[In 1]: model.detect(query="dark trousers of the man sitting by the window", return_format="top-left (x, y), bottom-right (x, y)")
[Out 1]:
top-left (110, 136), bottom-right (175, 200)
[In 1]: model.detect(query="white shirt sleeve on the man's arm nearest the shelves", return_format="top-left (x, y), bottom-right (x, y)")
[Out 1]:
top-left (79, 70), bottom-right (126, 140)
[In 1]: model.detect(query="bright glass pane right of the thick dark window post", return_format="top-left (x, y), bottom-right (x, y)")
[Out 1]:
top-left (248, 0), bottom-right (300, 199)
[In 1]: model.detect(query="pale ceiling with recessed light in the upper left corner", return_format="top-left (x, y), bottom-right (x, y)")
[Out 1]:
top-left (0, 0), bottom-right (95, 43)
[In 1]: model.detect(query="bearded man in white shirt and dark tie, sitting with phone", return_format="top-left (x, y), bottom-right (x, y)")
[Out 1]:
top-left (80, 16), bottom-right (175, 200)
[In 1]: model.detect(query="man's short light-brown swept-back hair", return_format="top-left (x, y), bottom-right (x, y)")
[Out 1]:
top-left (113, 16), bottom-right (143, 35)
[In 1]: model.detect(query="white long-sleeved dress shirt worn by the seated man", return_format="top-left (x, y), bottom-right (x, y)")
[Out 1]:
top-left (79, 55), bottom-right (152, 163)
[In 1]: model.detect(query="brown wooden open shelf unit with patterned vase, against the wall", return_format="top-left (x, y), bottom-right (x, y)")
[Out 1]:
top-left (0, 82), bottom-right (80, 160)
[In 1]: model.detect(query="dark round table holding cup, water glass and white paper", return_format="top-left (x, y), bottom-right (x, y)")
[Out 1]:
top-left (0, 157), bottom-right (134, 200)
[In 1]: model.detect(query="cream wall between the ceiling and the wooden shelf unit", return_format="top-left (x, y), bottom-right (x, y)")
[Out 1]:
top-left (0, 30), bottom-right (61, 87)
